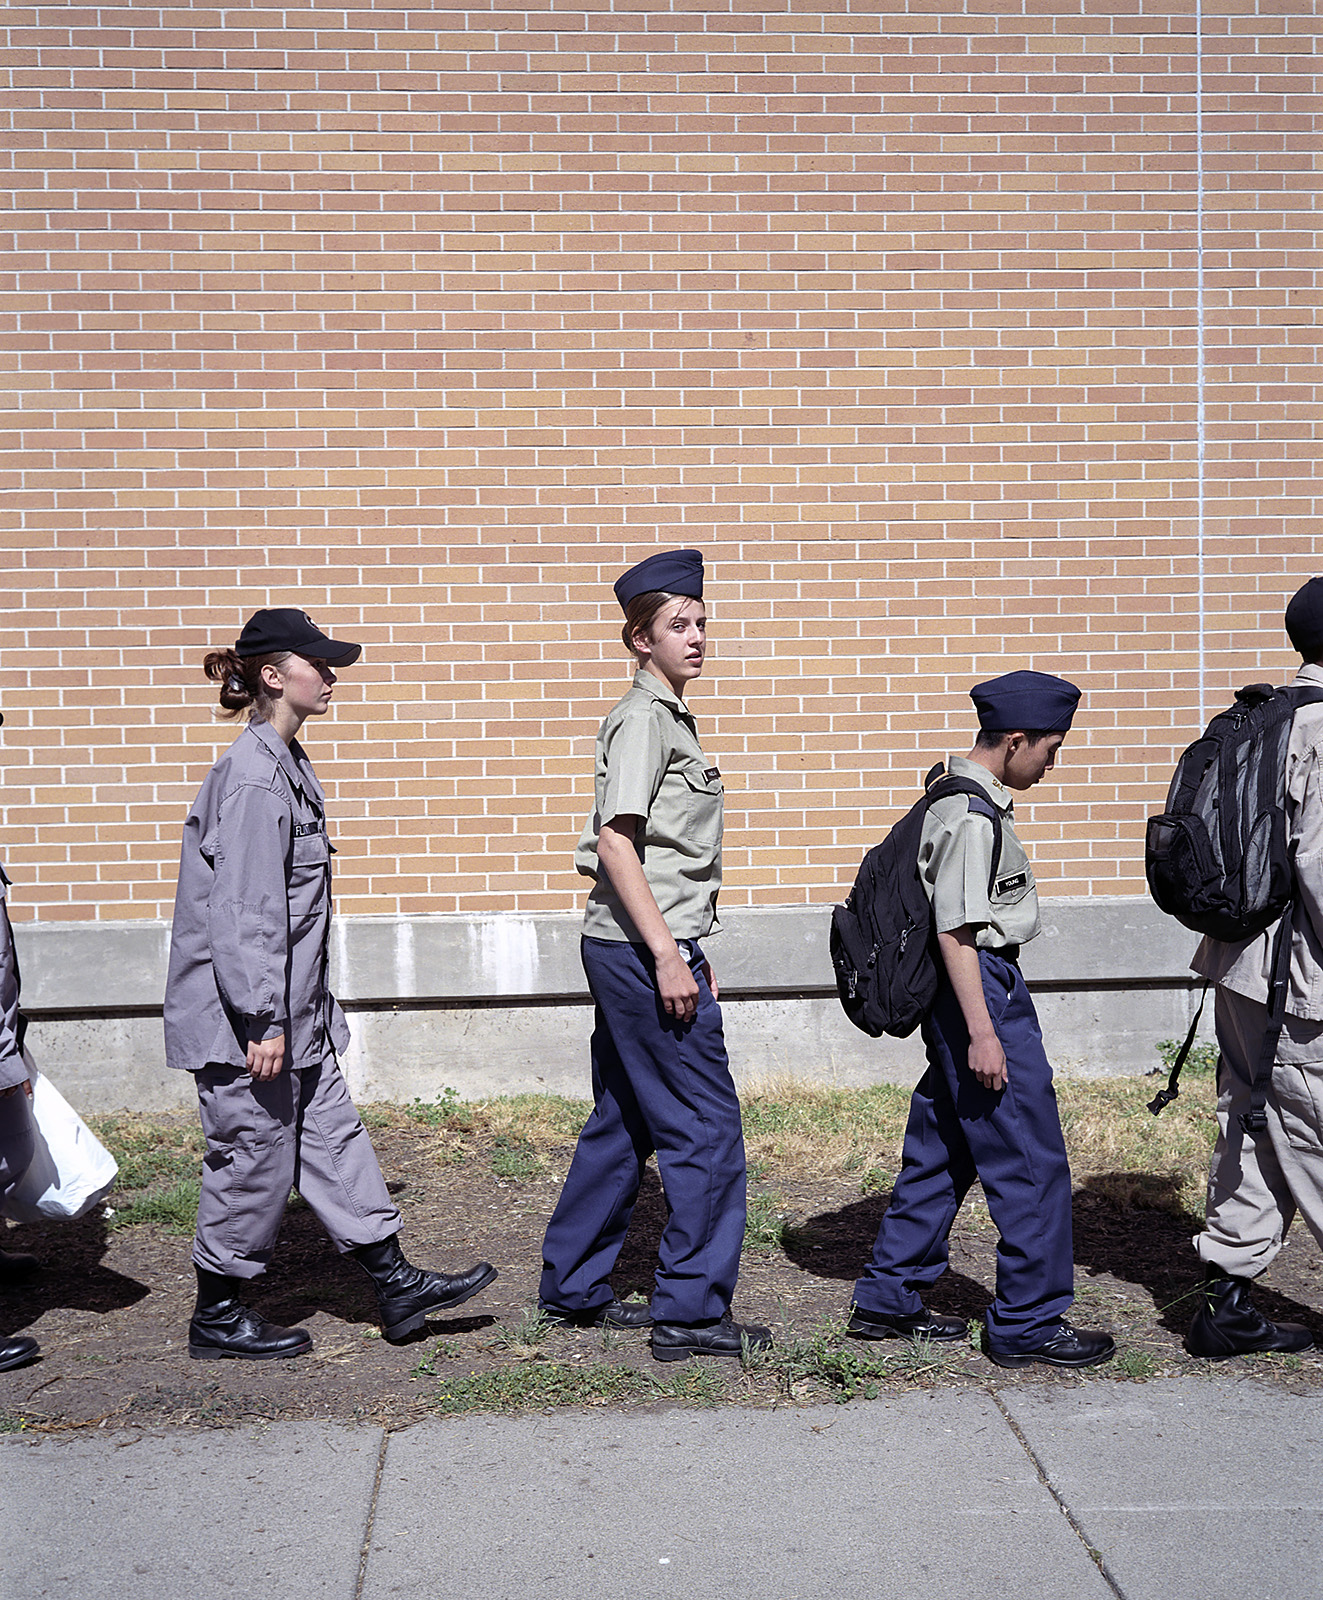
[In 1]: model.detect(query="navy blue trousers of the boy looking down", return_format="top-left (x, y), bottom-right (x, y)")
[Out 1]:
top-left (854, 950), bottom-right (1075, 1352)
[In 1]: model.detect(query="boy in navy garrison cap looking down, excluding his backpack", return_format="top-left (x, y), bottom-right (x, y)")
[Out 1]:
top-left (848, 672), bottom-right (1115, 1366)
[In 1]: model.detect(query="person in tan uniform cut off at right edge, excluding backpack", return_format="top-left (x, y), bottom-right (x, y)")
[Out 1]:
top-left (1185, 578), bottom-right (1323, 1360)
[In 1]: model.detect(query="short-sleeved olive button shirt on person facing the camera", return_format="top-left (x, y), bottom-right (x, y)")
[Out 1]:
top-left (574, 670), bottom-right (723, 944)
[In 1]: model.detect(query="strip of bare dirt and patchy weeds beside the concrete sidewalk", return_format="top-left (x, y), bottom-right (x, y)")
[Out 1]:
top-left (0, 1109), bottom-right (1323, 1430)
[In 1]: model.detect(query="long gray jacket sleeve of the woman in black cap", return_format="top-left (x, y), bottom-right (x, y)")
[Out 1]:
top-left (206, 784), bottom-right (290, 1043)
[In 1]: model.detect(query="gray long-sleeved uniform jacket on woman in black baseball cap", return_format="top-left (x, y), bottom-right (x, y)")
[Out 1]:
top-left (165, 722), bottom-right (349, 1072)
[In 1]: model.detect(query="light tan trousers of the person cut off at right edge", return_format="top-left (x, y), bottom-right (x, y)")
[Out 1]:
top-left (1195, 984), bottom-right (1323, 1278)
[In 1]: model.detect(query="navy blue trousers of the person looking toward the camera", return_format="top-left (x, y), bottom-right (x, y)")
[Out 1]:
top-left (539, 939), bottom-right (744, 1323)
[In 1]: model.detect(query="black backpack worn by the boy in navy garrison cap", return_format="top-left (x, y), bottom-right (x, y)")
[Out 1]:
top-left (830, 762), bottom-right (1001, 1038)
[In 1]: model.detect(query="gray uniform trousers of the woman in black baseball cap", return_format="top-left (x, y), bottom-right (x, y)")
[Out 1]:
top-left (194, 1061), bottom-right (400, 1278)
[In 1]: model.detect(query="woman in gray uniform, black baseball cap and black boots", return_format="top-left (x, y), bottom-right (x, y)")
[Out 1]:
top-left (165, 610), bottom-right (496, 1360)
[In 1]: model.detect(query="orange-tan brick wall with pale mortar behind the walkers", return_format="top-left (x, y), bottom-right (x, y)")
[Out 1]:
top-left (0, 0), bottom-right (1323, 918)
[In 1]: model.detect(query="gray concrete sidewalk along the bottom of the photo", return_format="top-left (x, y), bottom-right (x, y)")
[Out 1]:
top-left (0, 1379), bottom-right (1323, 1600)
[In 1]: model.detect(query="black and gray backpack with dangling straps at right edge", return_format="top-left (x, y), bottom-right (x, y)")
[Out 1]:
top-left (1144, 683), bottom-right (1323, 1133)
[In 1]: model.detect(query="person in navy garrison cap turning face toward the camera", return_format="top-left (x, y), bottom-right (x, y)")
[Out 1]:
top-left (539, 550), bottom-right (771, 1362)
